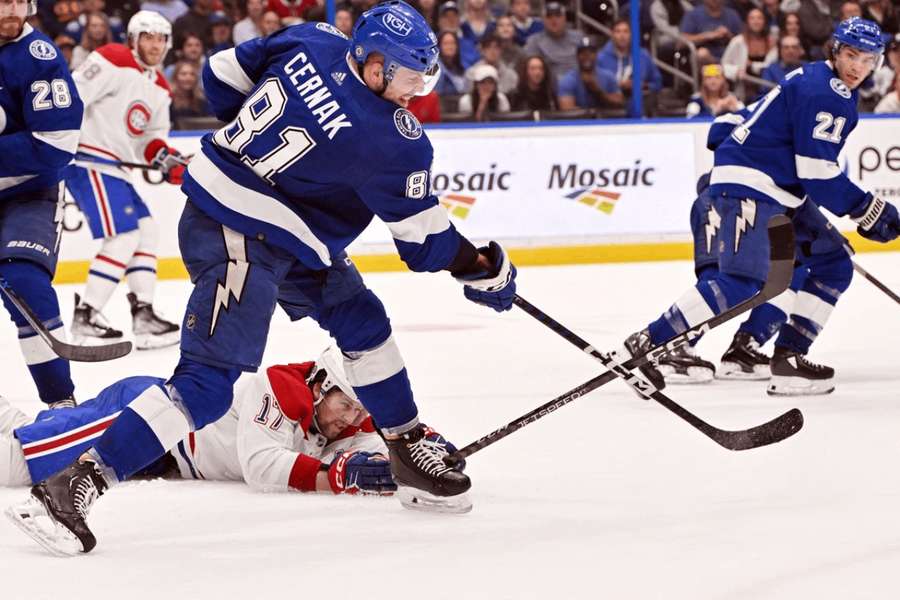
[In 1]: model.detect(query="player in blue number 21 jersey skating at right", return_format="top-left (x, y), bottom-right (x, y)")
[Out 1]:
top-left (625, 18), bottom-right (900, 394)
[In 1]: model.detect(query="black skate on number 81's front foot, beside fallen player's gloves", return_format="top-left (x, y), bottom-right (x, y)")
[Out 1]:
top-left (385, 423), bottom-right (472, 513)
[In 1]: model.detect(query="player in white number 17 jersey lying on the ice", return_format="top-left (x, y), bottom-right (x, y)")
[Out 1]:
top-left (0, 347), bottom-right (397, 516)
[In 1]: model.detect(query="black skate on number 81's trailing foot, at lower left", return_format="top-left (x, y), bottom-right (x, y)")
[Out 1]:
top-left (6, 460), bottom-right (109, 556)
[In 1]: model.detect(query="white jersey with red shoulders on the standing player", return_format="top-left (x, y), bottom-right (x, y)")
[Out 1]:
top-left (72, 44), bottom-right (172, 179)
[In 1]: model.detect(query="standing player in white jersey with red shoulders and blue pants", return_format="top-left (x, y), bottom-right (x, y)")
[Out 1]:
top-left (66, 10), bottom-right (186, 349)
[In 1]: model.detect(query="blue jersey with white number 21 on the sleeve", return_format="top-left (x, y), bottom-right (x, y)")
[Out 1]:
top-left (710, 62), bottom-right (866, 215)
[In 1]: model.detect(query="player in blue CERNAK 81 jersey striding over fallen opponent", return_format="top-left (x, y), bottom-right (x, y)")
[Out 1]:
top-left (12, 0), bottom-right (516, 552)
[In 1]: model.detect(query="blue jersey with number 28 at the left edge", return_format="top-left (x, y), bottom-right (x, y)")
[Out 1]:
top-left (0, 23), bottom-right (84, 200)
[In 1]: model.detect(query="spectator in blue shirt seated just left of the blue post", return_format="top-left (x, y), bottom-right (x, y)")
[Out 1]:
top-left (559, 36), bottom-right (625, 110)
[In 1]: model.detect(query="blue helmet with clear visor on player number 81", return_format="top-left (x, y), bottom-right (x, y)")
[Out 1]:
top-left (350, 0), bottom-right (440, 94)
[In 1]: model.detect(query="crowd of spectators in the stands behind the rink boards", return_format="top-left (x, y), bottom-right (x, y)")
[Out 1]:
top-left (31, 0), bottom-right (900, 122)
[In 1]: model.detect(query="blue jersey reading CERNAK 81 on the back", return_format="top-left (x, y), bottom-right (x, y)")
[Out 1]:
top-left (183, 23), bottom-right (461, 271)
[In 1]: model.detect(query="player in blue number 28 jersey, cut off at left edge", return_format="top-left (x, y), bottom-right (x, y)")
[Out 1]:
top-left (0, 0), bottom-right (83, 407)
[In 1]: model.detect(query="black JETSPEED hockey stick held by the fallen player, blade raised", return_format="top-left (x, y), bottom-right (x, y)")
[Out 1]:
top-left (446, 217), bottom-right (802, 464)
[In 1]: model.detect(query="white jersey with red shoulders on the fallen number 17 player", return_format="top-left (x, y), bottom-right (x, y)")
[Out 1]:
top-left (171, 362), bottom-right (388, 491)
